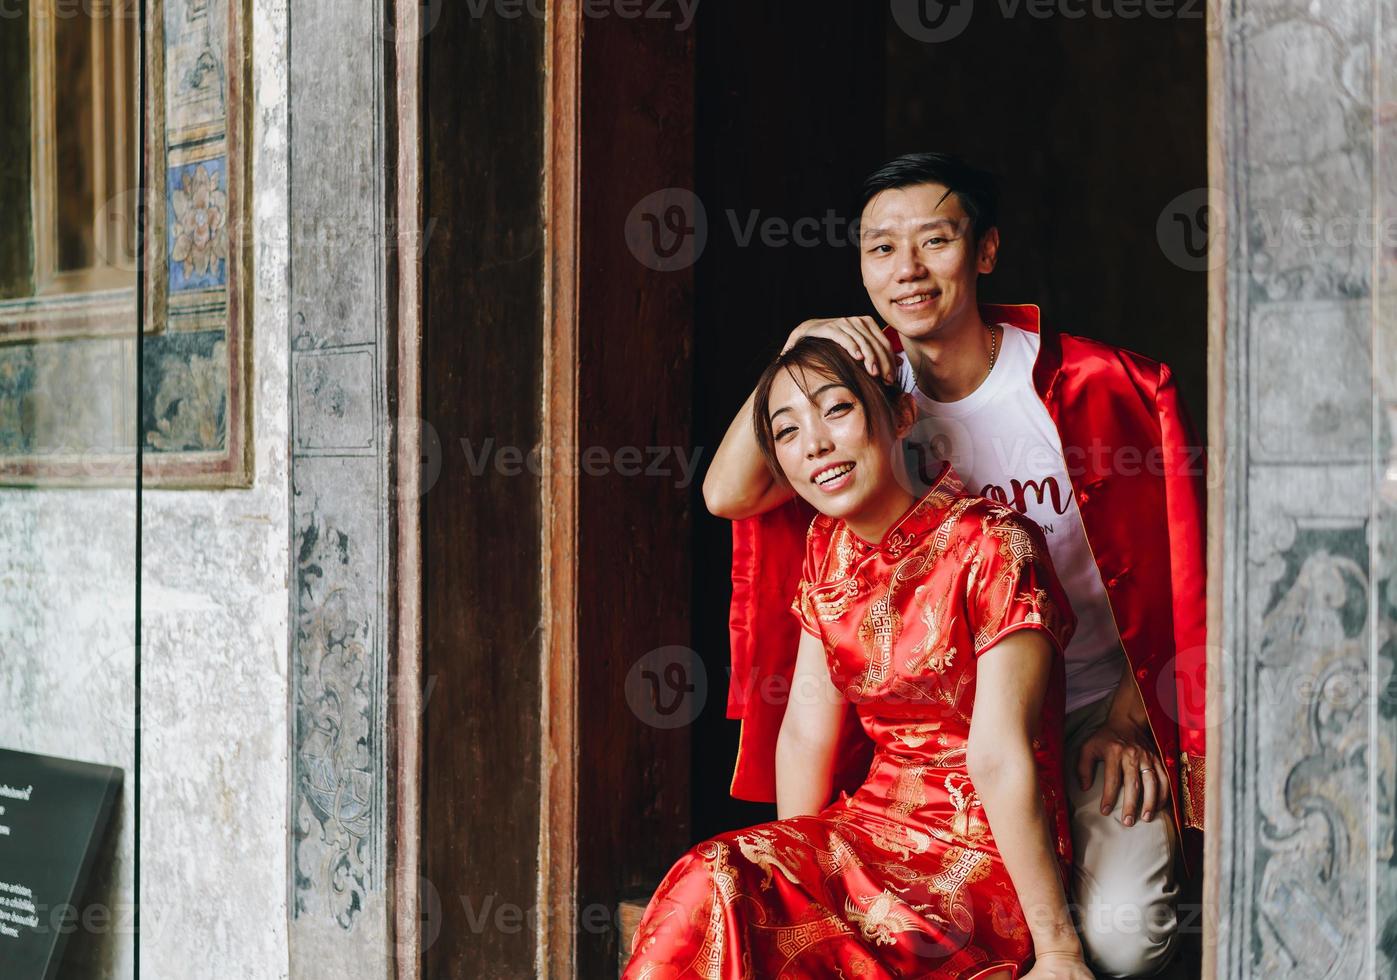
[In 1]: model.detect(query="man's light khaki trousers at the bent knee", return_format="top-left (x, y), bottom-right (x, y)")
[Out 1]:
top-left (1063, 695), bottom-right (1179, 977)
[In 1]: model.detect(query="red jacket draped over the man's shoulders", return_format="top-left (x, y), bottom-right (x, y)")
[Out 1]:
top-left (728, 306), bottom-right (1207, 867)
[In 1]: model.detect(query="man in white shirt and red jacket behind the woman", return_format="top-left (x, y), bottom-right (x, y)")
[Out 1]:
top-left (704, 154), bottom-right (1206, 976)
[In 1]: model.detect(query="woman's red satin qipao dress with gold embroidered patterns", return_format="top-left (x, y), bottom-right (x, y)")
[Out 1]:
top-left (623, 468), bottom-right (1074, 980)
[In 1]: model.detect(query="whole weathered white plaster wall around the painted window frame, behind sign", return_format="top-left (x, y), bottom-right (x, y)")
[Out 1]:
top-left (0, 0), bottom-right (291, 980)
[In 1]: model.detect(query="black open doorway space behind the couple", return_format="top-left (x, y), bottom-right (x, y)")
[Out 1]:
top-left (692, 0), bottom-right (1207, 966)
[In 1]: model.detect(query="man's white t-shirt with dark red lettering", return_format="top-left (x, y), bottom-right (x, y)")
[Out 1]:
top-left (898, 324), bottom-right (1123, 711)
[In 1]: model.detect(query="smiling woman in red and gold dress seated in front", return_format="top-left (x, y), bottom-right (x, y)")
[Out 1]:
top-left (623, 338), bottom-right (1091, 980)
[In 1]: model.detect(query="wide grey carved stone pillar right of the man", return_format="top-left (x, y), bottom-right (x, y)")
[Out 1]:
top-left (1213, 0), bottom-right (1397, 980)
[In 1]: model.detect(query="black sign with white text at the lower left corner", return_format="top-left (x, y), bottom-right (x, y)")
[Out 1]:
top-left (0, 748), bottom-right (122, 980)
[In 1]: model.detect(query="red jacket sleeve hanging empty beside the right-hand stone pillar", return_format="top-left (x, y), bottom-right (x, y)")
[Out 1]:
top-left (1155, 364), bottom-right (1207, 831)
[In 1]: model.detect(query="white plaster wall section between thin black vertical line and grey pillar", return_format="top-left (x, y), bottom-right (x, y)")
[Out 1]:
top-left (141, 0), bottom-right (291, 980)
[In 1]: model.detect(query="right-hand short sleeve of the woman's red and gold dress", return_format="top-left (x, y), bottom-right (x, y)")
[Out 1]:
top-left (967, 511), bottom-right (1077, 656)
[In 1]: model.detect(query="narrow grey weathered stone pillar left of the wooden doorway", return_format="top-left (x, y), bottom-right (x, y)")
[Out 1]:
top-left (286, 0), bottom-right (395, 980)
